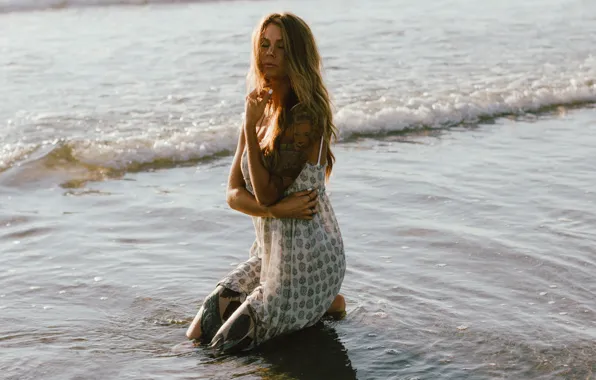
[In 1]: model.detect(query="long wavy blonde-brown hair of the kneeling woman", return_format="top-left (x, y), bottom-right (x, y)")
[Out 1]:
top-left (247, 13), bottom-right (338, 179)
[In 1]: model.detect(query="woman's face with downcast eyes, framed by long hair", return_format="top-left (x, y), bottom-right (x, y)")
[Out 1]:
top-left (259, 24), bottom-right (286, 79)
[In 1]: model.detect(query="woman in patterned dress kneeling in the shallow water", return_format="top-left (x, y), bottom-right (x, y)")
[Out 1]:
top-left (187, 13), bottom-right (345, 352)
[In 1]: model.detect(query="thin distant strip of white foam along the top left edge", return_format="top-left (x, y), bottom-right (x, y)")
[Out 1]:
top-left (0, 0), bottom-right (232, 14)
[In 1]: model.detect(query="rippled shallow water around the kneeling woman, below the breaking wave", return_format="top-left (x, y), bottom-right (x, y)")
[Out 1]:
top-left (0, 109), bottom-right (596, 379)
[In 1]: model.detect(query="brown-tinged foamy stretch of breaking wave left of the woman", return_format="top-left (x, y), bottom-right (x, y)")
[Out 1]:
top-left (0, 128), bottom-right (238, 188)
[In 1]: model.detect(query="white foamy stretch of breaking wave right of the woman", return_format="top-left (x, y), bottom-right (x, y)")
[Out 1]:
top-left (335, 79), bottom-right (596, 139)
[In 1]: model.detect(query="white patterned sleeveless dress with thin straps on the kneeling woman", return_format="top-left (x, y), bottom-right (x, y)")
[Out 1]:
top-left (199, 137), bottom-right (346, 351)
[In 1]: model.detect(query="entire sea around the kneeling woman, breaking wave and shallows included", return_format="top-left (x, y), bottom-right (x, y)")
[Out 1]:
top-left (0, 0), bottom-right (596, 380)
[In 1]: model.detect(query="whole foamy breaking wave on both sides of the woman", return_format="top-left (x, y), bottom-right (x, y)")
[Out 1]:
top-left (0, 80), bottom-right (596, 181)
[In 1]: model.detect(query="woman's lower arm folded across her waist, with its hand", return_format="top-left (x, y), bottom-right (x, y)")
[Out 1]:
top-left (226, 130), bottom-right (317, 219)
